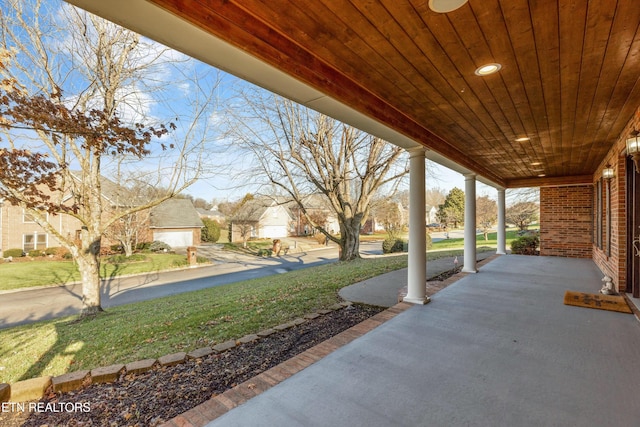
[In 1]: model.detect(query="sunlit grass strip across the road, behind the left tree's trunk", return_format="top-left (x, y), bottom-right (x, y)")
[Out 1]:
top-left (0, 254), bottom-right (204, 291)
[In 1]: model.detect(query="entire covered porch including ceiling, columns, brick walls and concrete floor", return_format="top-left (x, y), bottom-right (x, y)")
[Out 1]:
top-left (61, 0), bottom-right (640, 426)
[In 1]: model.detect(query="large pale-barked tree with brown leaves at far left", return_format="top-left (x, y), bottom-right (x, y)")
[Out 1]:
top-left (0, 0), bottom-right (221, 315)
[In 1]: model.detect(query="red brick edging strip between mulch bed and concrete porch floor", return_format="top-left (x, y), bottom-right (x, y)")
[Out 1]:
top-left (160, 302), bottom-right (413, 427)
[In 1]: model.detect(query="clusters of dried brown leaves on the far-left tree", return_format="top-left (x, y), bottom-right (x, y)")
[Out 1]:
top-left (0, 80), bottom-right (175, 212)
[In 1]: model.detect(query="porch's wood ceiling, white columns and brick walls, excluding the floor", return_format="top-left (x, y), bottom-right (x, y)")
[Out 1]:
top-left (68, 0), bottom-right (640, 310)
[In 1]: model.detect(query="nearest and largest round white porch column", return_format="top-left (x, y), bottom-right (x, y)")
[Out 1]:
top-left (403, 147), bottom-right (429, 304)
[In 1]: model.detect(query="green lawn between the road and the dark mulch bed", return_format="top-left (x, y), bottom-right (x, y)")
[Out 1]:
top-left (0, 247), bottom-right (470, 383)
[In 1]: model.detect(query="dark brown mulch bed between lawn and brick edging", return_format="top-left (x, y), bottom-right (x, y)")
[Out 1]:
top-left (0, 304), bottom-right (384, 427)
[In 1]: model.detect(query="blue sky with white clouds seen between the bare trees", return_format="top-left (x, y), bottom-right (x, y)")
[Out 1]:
top-left (0, 1), bottom-right (496, 206)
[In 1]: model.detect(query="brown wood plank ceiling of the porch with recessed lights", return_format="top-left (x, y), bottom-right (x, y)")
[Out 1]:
top-left (138, 0), bottom-right (640, 187)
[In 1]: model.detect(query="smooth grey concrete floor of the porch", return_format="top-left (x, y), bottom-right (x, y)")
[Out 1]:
top-left (198, 255), bottom-right (640, 427)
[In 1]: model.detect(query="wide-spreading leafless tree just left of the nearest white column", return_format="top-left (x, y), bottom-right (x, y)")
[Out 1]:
top-left (232, 90), bottom-right (408, 261)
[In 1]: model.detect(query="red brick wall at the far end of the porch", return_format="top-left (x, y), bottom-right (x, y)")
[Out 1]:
top-left (540, 185), bottom-right (593, 258)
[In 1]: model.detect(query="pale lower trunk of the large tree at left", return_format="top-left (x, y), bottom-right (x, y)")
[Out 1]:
top-left (76, 237), bottom-right (103, 317)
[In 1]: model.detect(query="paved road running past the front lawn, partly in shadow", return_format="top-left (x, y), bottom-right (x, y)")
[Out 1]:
top-left (0, 242), bottom-right (381, 329)
